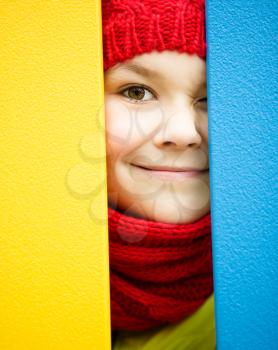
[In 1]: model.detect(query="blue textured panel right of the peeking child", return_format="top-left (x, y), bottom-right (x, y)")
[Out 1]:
top-left (206, 0), bottom-right (278, 350)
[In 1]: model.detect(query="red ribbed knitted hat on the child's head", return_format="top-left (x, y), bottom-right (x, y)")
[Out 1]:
top-left (102, 0), bottom-right (206, 70)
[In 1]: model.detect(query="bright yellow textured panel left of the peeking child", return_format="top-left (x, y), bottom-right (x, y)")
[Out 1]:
top-left (0, 0), bottom-right (110, 350)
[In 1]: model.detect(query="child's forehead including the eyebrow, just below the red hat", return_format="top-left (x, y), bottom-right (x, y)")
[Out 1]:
top-left (106, 51), bottom-right (206, 86)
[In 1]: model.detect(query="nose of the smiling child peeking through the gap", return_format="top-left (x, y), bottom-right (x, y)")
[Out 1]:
top-left (153, 102), bottom-right (202, 149)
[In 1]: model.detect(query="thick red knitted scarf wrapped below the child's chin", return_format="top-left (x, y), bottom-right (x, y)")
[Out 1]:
top-left (108, 207), bottom-right (213, 331)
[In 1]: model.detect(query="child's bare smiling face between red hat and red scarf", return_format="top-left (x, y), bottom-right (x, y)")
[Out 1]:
top-left (105, 51), bottom-right (210, 224)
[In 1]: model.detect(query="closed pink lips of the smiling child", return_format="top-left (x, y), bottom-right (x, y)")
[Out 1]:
top-left (131, 164), bottom-right (208, 181)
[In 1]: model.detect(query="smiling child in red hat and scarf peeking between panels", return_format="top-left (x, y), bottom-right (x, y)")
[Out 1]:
top-left (102, 0), bottom-right (215, 350)
